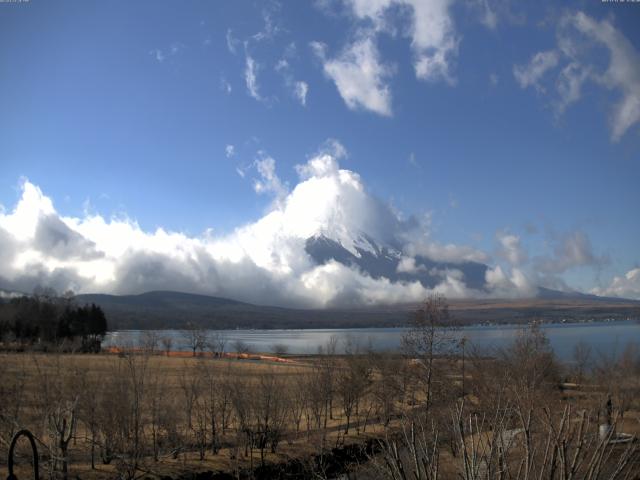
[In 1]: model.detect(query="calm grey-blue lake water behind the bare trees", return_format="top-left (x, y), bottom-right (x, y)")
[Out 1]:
top-left (104, 321), bottom-right (640, 361)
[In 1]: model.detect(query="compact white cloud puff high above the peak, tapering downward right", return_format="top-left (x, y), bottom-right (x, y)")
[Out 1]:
top-left (312, 32), bottom-right (393, 116)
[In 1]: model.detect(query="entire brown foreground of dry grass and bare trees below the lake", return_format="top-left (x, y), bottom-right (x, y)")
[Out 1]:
top-left (0, 320), bottom-right (640, 480)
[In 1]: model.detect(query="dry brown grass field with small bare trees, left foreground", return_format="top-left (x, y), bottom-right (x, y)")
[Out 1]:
top-left (0, 353), bottom-right (410, 479)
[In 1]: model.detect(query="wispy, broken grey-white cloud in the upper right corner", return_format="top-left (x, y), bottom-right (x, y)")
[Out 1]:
top-left (514, 12), bottom-right (640, 142)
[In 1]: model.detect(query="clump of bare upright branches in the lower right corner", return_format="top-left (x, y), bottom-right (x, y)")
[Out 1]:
top-left (372, 401), bottom-right (640, 480)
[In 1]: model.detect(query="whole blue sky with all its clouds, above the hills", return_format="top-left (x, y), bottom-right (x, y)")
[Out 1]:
top-left (0, 0), bottom-right (640, 307)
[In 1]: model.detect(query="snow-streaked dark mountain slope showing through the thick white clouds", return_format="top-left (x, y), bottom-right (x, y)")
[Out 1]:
top-left (305, 234), bottom-right (489, 290)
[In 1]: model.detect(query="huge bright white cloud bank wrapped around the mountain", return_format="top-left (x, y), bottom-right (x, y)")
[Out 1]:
top-left (0, 140), bottom-right (510, 307)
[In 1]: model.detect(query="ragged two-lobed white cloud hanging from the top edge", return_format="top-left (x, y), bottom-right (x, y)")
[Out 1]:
top-left (312, 0), bottom-right (508, 116)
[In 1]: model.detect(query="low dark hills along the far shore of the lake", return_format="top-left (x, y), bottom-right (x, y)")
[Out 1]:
top-left (76, 291), bottom-right (640, 330)
